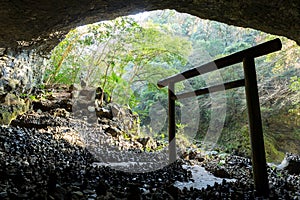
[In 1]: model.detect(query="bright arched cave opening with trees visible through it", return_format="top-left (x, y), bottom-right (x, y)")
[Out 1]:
top-left (44, 10), bottom-right (298, 170)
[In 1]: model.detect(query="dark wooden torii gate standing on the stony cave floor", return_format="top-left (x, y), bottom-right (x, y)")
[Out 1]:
top-left (157, 38), bottom-right (282, 197)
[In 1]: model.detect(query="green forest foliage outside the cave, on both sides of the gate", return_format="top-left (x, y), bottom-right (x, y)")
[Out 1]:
top-left (45, 10), bottom-right (300, 160)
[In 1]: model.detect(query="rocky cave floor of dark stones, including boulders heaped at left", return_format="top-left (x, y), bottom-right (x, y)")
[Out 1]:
top-left (0, 86), bottom-right (300, 200)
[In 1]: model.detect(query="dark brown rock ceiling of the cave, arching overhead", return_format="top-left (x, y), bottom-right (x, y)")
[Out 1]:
top-left (0, 0), bottom-right (300, 50)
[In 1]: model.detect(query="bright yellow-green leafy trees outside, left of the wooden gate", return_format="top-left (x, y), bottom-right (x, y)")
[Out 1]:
top-left (46, 17), bottom-right (191, 106)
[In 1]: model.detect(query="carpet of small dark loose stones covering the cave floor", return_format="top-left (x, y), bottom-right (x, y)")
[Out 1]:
top-left (0, 89), bottom-right (300, 200)
